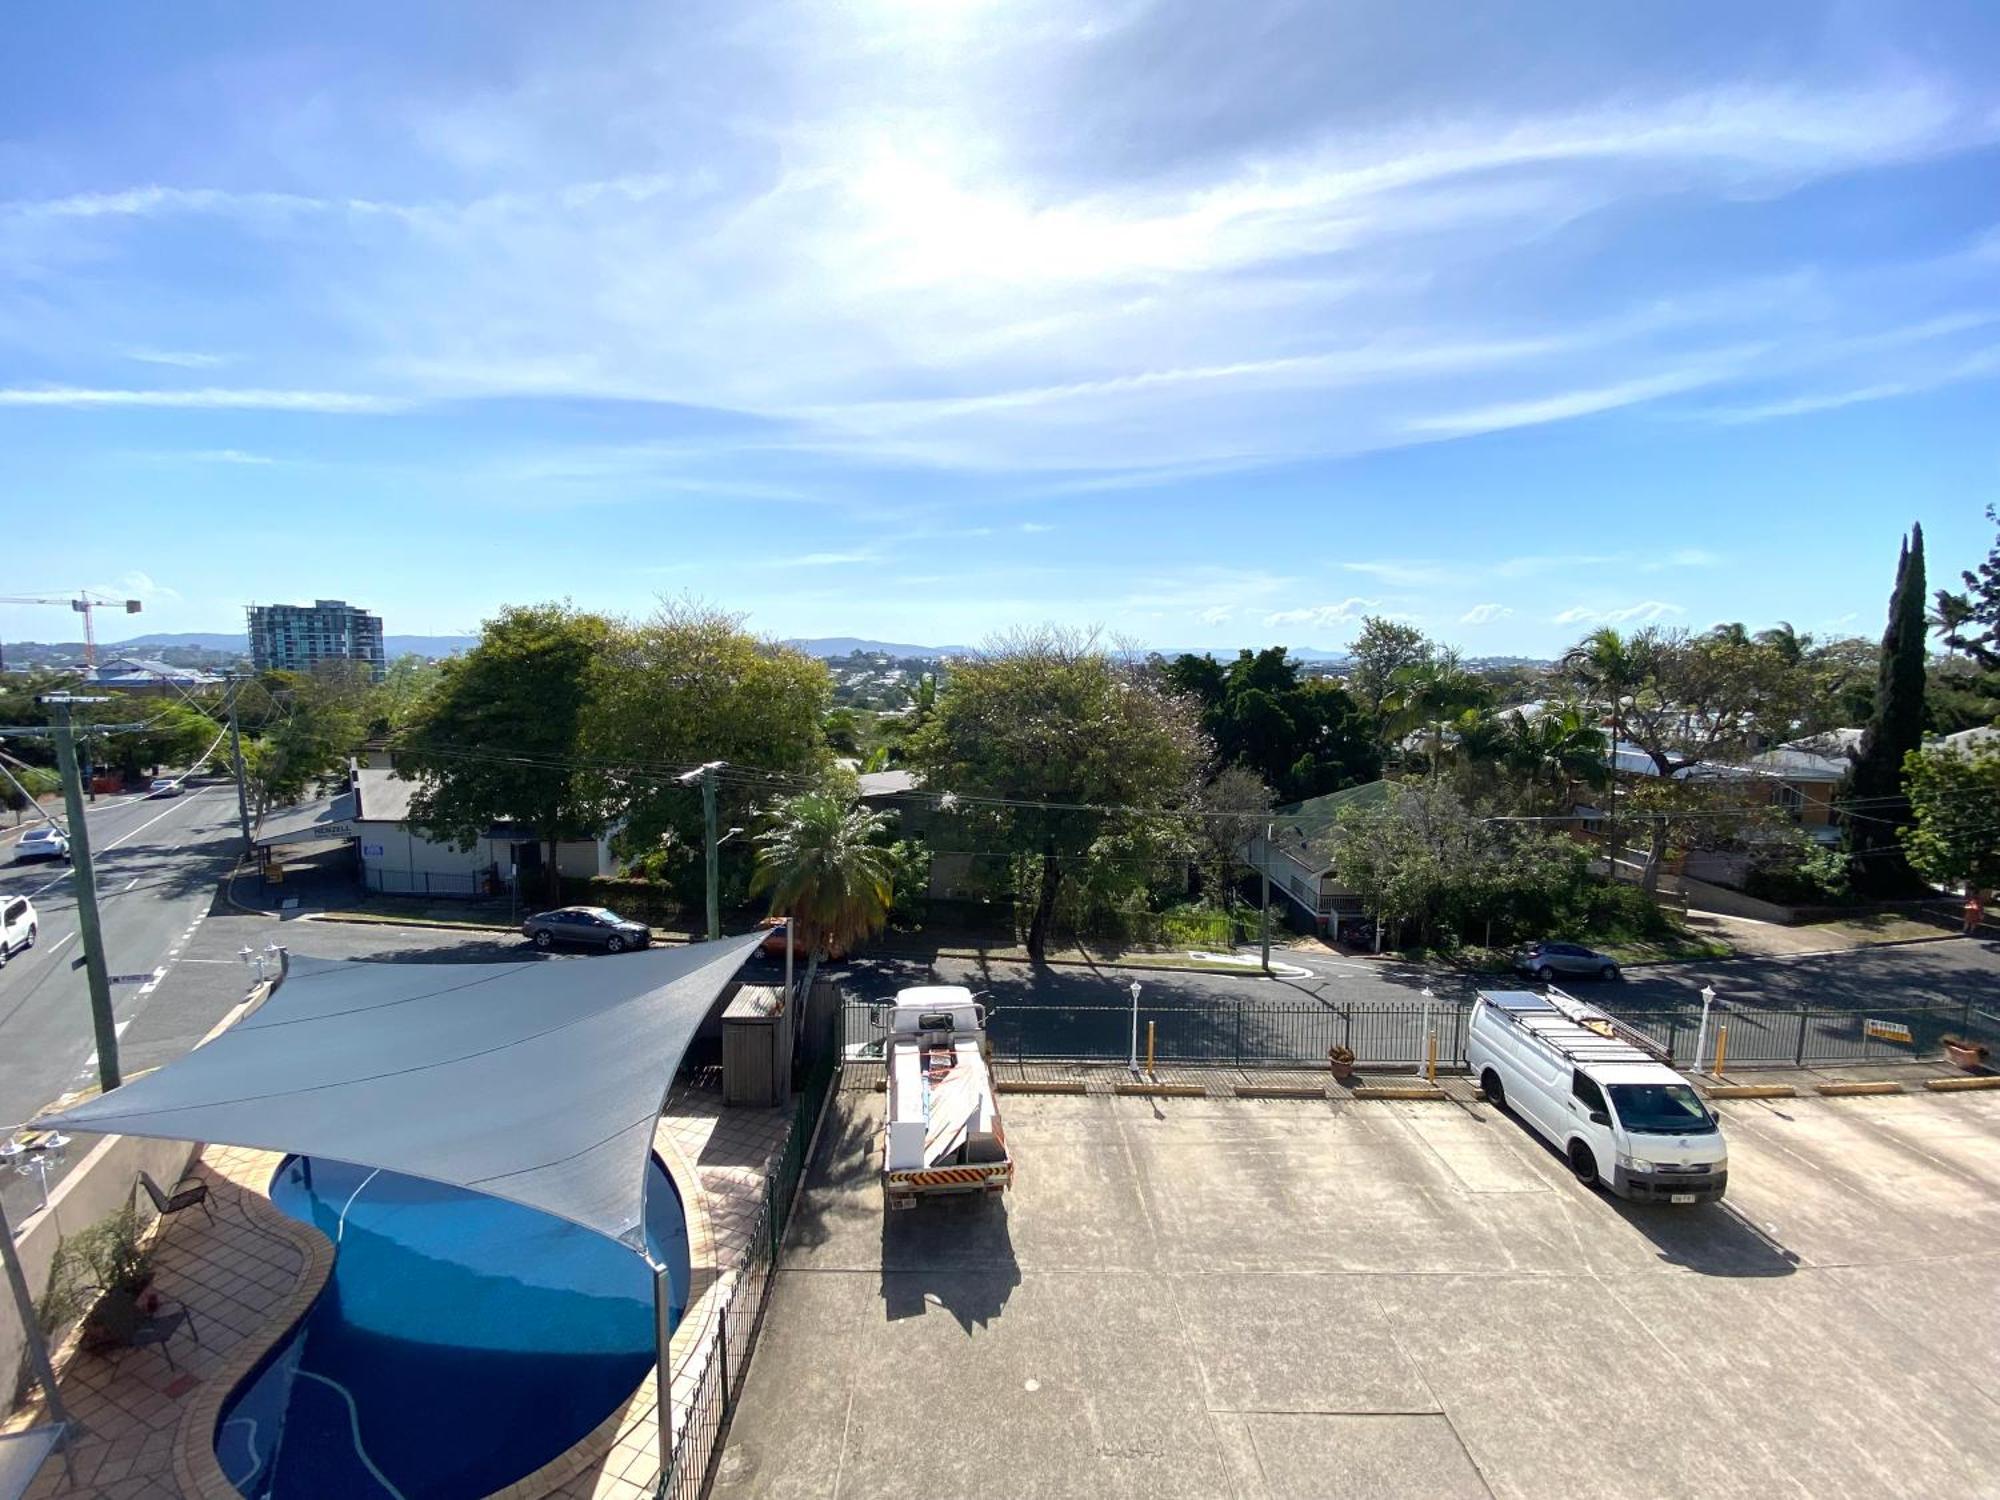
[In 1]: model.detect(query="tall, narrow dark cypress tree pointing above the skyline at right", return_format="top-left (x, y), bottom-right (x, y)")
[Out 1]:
top-left (1840, 526), bottom-right (1928, 896)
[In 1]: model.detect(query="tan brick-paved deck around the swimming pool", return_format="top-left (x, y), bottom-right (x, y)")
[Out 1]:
top-left (0, 1086), bottom-right (792, 1500)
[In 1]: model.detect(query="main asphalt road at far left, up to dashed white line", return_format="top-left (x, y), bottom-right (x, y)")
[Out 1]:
top-left (0, 786), bottom-right (238, 1126)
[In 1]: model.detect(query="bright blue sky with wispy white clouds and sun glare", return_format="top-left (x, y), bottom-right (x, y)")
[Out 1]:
top-left (0, 0), bottom-right (2000, 654)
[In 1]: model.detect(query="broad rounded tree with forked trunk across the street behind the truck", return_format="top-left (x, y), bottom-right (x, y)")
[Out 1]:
top-left (910, 626), bottom-right (1212, 962)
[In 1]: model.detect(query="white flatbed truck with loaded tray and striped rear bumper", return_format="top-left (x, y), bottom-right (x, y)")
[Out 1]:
top-left (882, 984), bottom-right (1014, 1208)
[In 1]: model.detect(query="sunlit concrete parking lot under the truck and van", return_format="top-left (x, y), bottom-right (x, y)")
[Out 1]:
top-left (716, 1090), bottom-right (2000, 1500)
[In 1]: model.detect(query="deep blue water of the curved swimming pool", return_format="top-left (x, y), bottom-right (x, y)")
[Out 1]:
top-left (216, 1156), bottom-right (688, 1500)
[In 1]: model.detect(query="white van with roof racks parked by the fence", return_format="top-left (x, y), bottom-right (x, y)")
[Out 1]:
top-left (1466, 988), bottom-right (1730, 1204)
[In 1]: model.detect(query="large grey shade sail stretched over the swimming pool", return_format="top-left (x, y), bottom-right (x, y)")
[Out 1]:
top-left (36, 932), bottom-right (764, 1254)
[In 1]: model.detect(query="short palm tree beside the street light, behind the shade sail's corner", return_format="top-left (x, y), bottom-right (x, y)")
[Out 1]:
top-left (750, 792), bottom-right (896, 958)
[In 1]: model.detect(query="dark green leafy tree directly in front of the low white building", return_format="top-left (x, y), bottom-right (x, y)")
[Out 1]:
top-left (396, 604), bottom-right (614, 900)
